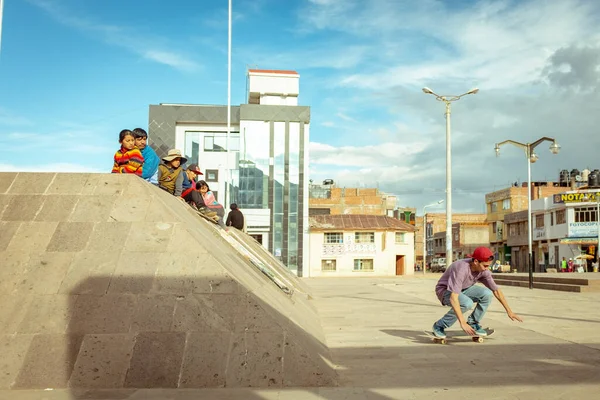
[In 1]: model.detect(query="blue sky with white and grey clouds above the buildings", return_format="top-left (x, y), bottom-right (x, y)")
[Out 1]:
top-left (0, 0), bottom-right (600, 214)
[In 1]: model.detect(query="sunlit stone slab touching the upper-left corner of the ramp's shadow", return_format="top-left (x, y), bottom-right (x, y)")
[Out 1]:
top-left (16, 253), bottom-right (73, 294)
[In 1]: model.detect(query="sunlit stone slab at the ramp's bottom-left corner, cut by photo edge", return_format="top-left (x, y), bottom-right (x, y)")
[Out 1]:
top-left (0, 335), bottom-right (33, 389)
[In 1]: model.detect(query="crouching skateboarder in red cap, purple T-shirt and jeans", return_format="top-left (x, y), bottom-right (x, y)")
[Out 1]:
top-left (433, 247), bottom-right (523, 338)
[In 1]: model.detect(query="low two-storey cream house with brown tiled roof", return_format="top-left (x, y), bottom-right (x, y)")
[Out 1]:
top-left (307, 214), bottom-right (415, 277)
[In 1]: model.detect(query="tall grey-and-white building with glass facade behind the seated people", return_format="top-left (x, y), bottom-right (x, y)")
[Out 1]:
top-left (148, 69), bottom-right (310, 276)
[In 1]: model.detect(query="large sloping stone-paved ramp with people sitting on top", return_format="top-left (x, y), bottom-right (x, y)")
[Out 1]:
top-left (0, 173), bottom-right (336, 389)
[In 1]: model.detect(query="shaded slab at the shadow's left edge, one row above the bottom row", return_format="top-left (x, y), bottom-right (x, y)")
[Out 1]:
top-left (68, 294), bottom-right (137, 334)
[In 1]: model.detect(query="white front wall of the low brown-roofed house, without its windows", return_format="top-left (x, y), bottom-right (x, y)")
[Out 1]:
top-left (305, 231), bottom-right (415, 277)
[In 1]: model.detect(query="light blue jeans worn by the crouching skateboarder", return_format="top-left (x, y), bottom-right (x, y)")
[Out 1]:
top-left (435, 285), bottom-right (493, 329)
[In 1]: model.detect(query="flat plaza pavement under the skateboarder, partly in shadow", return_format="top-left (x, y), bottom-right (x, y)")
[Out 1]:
top-left (0, 274), bottom-right (600, 400)
